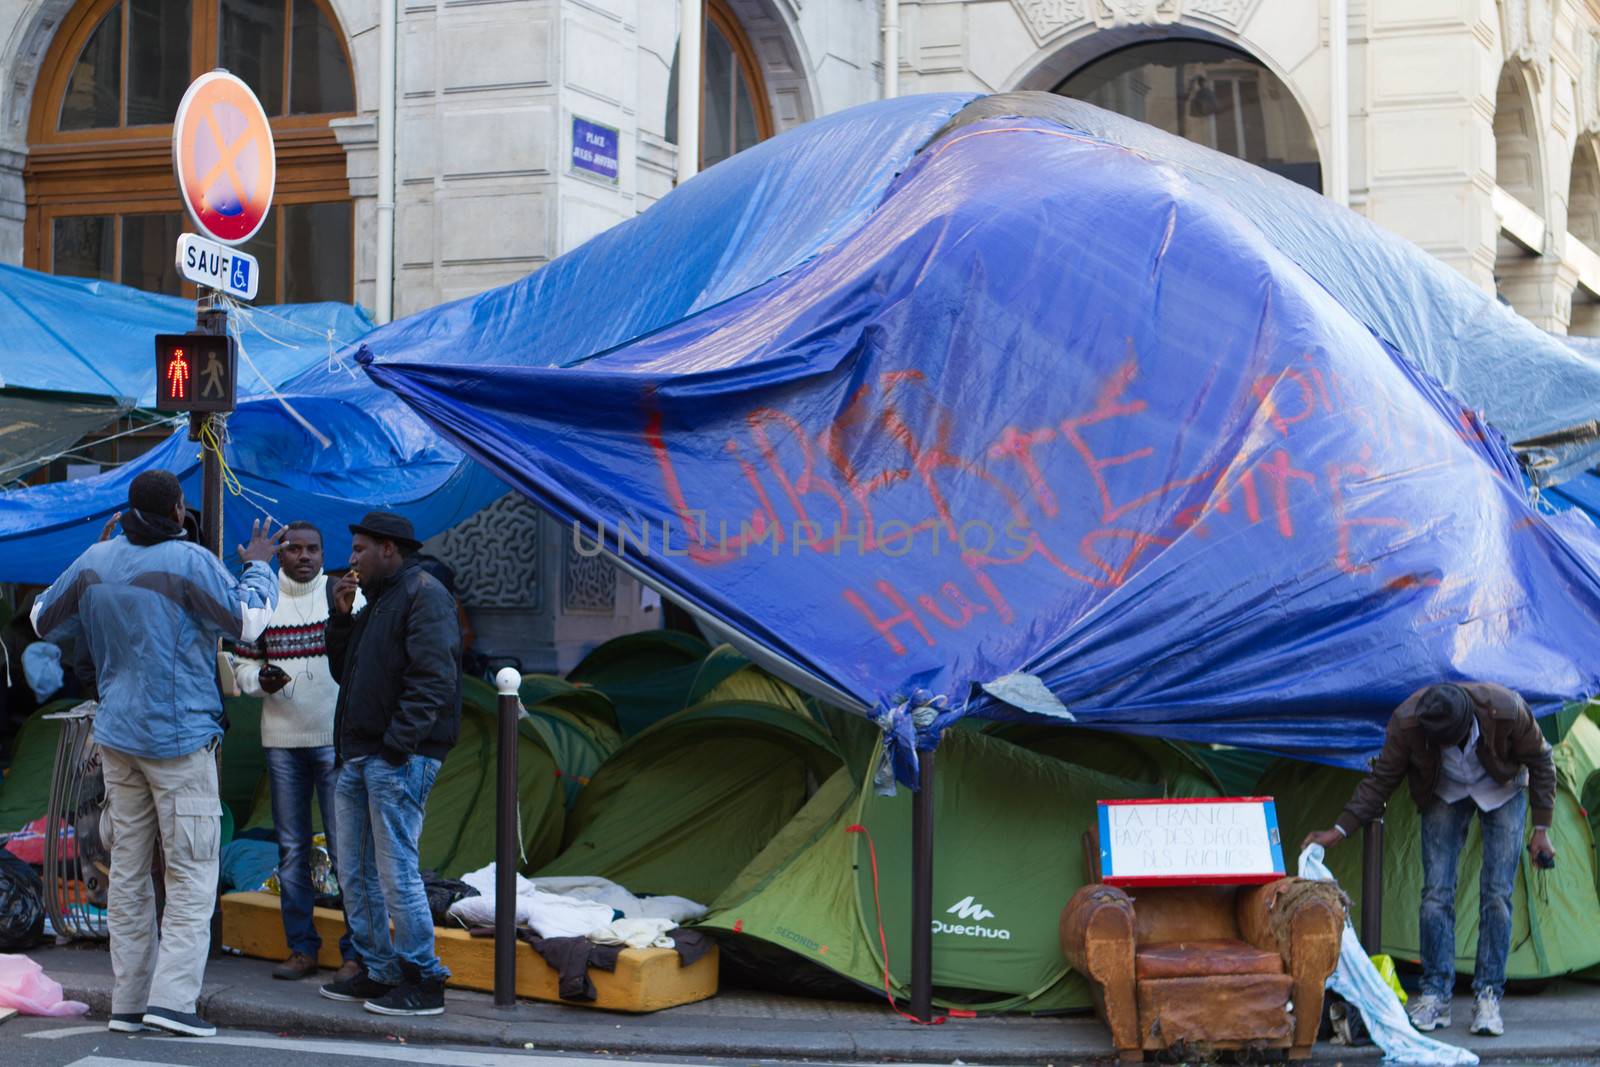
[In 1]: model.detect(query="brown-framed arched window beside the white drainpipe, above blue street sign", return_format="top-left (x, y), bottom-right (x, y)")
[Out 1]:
top-left (667, 0), bottom-right (773, 170)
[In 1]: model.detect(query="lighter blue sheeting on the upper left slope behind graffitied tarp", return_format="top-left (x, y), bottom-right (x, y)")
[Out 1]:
top-left (337, 93), bottom-right (973, 375)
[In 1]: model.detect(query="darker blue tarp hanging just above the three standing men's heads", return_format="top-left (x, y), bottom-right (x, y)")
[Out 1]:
top-left (0, 350), bottom-right (506, 584)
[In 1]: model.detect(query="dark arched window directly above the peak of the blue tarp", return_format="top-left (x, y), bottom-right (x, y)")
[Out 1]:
top-left (1054, 37), bottom-right (1322, 192)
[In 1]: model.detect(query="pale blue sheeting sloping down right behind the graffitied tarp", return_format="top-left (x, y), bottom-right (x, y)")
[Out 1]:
top-left (952, 93), bottom-right (1600, 485)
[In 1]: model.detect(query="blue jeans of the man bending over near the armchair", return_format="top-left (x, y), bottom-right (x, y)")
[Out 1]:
top-left (1421, 792), bottom-right (1528, 1001)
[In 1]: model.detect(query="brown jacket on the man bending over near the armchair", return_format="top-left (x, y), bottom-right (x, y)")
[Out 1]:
top-left (1338, 681), bottom-right (1555, 833)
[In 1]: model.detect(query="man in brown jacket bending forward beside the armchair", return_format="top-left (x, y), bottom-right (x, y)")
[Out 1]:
top-left (1301, 681), bottom-right (1555, 1037)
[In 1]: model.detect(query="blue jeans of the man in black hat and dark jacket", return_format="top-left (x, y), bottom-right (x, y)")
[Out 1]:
top-left (334, 755), bottom-right (450, 985)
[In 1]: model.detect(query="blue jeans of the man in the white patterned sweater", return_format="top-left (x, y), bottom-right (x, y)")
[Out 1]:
top-left (264, 745), bottom-right (355, 960)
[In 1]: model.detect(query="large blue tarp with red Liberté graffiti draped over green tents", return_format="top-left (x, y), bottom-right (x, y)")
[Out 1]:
top-left (357, 98), bottom-right (1600, 771)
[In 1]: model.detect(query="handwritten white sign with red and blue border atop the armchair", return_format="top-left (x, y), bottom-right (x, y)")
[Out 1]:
top-left (1099, 797), bottom-right (1283, 886)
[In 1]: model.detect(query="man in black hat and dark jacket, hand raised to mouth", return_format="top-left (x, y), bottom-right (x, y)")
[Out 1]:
top-left (322, 512), bottom-right (461, 1016)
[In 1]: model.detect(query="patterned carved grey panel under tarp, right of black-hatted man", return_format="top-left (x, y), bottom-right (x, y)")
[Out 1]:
top-left (424, 493), bottom-right (539, 609)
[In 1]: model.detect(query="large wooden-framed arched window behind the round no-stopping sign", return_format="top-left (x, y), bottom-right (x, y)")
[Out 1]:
top-left (26, 0), bottom-right (355, 304)
